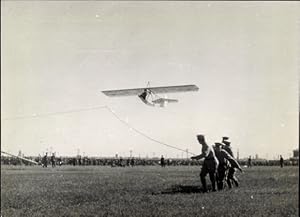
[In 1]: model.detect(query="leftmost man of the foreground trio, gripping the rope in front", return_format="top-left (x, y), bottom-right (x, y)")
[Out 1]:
top-left (191, 135), bottom-right (219, 192)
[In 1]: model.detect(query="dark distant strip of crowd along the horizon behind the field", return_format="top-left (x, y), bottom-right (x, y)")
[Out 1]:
top-left (1, 156), bottom-right (299, 167)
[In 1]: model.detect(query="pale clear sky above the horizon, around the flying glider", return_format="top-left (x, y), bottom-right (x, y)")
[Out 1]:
top-left (1, 1), bottom-right (300, 159)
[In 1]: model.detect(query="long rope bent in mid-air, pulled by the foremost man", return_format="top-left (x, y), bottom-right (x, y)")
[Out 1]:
top-left (1, 106), bottom-right (195, 155)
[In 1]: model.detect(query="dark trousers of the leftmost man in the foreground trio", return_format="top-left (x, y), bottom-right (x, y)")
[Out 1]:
top-left (200, 160), bottom-right (216, 192)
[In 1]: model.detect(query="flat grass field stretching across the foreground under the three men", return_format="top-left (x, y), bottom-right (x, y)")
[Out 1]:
top-left (1, 166), bottom-right (299, 217)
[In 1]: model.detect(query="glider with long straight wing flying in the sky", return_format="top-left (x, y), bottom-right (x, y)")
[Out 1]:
top-left (102, 83), bottom-right (199, 107)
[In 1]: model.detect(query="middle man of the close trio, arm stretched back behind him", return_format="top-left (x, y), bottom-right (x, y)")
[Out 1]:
top-left (215, 142), bottom-right (242, 190)
